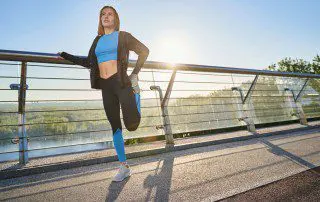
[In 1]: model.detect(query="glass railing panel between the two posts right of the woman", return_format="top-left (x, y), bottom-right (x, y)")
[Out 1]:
top-left (168, 71), bottom-right (240, 133)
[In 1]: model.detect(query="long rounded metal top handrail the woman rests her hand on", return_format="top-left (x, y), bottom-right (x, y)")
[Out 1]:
top-left (0, 49), bottom-right (320, 79)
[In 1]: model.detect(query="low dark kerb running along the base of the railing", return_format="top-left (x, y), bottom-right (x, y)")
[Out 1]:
top-left (0, 125), bottom-right (320, 180)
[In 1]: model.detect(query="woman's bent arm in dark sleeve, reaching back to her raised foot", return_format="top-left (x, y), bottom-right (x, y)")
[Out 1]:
top-left (128, 33), bottom-right (149, 74)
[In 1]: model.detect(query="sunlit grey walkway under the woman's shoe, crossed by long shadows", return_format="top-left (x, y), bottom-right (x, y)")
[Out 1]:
top-left (0, 125), bottom-right (320, 201)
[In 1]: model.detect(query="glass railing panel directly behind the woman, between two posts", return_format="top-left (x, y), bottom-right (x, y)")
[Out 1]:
top-left (26, 63), bottom-right (163, 156)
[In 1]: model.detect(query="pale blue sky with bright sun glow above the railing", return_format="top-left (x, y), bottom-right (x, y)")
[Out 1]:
top-left (0, 0), bottom-right (320, 69)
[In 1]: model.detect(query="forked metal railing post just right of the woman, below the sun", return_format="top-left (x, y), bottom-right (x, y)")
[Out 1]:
top-left (150, 70), bottom-right (176, 147)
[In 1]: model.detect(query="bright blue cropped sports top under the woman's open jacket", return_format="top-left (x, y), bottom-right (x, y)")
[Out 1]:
top-left (95, 31), bottom-right (119, 64)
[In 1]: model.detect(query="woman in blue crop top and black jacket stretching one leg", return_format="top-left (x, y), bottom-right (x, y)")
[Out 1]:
top-left (58, 6), bottom-right (149, 181)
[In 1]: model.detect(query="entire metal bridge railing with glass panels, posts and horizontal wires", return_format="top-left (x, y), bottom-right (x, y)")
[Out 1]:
top-left (0, 50), bottom-right (320, 164)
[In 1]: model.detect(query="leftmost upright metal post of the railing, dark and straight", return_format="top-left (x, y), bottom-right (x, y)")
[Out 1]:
top-left (18, 62), bottom-right (28, 165)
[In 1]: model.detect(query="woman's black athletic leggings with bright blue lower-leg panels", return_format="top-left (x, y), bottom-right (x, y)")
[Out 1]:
top-left (100, 73), bottom-right (141, 162)
